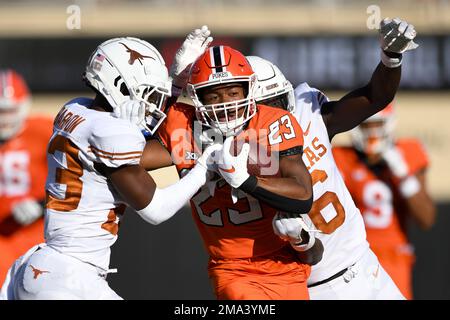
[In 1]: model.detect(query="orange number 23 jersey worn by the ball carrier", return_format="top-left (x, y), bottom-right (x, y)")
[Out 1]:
top-left (158, 103), bottom-right (303, 259)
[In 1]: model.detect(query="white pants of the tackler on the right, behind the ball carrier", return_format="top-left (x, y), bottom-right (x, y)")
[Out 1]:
top-left (308, 249), bottom-right (405, 300)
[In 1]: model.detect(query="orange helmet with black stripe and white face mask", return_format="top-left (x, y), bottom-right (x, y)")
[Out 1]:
top-left (187, 46), bottom-right (257, 136)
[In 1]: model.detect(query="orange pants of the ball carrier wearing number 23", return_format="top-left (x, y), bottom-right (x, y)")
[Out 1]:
top-left (208, 247), bottom-right (311, 300)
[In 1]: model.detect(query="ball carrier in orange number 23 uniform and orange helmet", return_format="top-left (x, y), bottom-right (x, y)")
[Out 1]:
top-left (141, 46), bottom-right (322, 299)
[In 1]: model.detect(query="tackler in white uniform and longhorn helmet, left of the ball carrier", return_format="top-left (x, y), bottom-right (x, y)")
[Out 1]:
top-left (0, 27), bottom-right (217, 299)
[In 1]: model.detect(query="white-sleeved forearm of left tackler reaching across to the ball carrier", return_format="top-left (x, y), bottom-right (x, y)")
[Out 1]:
top-left (136, 165), bottom-right (206, 225)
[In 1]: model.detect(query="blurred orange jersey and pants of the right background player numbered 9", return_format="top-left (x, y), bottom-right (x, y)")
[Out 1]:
top-left (333, 139), bottom-right (429, 299)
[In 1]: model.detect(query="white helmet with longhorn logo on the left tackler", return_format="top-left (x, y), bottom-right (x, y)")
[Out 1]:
top-left (83, 37), bottom-right (172, 134)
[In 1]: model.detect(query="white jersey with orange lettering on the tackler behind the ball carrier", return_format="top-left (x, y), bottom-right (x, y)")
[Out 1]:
top-left (294, 83), bottom-right (369, 284)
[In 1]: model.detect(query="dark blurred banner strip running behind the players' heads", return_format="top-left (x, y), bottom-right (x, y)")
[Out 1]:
top-left (0, 35), bottom-right (450, 92)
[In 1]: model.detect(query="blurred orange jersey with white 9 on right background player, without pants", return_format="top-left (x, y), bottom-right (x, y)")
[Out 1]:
top-left (333, 139), bottom-right (428, 246)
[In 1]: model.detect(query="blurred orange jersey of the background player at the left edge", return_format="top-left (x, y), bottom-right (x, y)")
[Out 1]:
top-left (0, 116), bottom-right (53, 281)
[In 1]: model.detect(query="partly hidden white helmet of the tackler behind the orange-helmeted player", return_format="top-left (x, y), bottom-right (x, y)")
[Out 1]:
top-left (246, 56), bottom-right (295, 112)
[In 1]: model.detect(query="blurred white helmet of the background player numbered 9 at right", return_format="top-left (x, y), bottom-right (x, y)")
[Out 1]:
top-left (350, 103), bottom-right (396, 155)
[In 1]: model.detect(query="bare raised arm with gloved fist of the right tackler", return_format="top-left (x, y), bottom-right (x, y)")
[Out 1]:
top-left (322, 19), bottom-right (418, 140)
